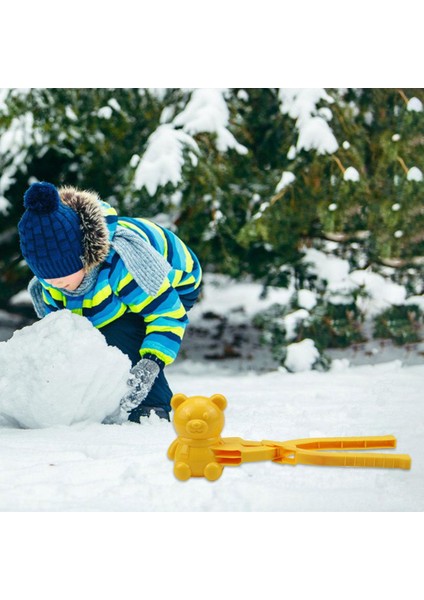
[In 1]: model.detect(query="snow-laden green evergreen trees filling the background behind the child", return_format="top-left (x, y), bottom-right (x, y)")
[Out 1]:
top-left (0, 88), bottom-right (424, 360)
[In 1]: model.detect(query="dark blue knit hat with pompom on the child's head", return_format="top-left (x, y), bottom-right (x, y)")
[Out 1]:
top-left (18, 181), bottom-right (84, 279)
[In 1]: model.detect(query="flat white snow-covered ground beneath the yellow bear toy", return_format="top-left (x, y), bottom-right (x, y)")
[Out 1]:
top-left (0, 363), bottom-right (424, 511)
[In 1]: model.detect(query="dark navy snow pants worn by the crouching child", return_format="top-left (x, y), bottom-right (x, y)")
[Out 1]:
top-left (99, 286), bottom-right (201, 411)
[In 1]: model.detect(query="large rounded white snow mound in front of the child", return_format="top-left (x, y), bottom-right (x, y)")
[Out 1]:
top-left (0, 310), bottom-right (131, 429)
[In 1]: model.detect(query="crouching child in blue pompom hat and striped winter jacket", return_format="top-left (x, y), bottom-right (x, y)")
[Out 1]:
top-left (18, 182), bottom-right (202, 422)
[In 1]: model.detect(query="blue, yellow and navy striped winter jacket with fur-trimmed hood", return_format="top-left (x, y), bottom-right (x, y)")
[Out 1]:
top-left (40, 187), bottom-right (202, 366)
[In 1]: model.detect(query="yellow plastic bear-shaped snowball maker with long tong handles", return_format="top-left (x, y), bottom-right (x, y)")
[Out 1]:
top-left (168, 394), bottom-right (411, 481)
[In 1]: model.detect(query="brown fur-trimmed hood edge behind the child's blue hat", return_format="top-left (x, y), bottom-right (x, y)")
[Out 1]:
top-left (58, 186), bottom-right (117, 271)
